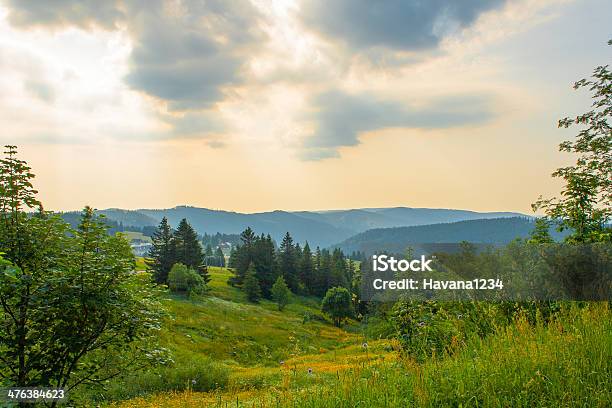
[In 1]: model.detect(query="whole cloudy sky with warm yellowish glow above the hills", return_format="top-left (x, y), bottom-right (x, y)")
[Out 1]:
top-left (0, 0), bottom-right (612, 213)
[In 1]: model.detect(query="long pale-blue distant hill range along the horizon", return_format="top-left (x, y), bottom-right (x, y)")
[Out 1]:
top-left (85, 206), bottom-right (523, 247)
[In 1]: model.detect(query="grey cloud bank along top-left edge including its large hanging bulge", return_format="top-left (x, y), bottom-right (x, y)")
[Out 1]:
top-left (8, 0), bottom-right (263, 137)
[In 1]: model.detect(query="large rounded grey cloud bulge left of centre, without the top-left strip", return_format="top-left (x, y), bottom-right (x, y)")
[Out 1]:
top-left (126, 0), bottom-right (261, 111)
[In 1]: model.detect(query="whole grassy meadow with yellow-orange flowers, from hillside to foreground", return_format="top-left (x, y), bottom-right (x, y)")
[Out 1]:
top-left (68, 267), bottom-right (612, 408)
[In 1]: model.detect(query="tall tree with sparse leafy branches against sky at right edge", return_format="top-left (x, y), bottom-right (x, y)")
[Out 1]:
top-left (532, 40), bottom-right (612, 243)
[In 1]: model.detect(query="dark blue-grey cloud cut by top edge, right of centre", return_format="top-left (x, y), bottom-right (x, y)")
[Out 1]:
top-left (302, 0), bottom-right (504, 50)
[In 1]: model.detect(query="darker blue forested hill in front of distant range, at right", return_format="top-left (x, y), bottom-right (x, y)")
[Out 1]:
top-left (335, 217), bottom-right (563, 254)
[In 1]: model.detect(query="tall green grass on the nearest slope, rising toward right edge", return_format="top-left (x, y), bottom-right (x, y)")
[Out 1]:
top-left (116, 303), bottom-right (612, 408)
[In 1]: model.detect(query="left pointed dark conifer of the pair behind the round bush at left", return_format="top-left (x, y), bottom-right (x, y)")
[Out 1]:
top-left (145, 217), bottom-right (176, 283)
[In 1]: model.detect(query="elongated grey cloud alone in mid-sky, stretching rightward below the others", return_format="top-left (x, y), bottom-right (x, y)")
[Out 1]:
top-left (300, 91), bottom-right (492, 160)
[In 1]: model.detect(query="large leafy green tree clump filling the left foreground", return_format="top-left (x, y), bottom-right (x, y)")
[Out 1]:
top-left (0, 146), bottom-right (164, 398)
